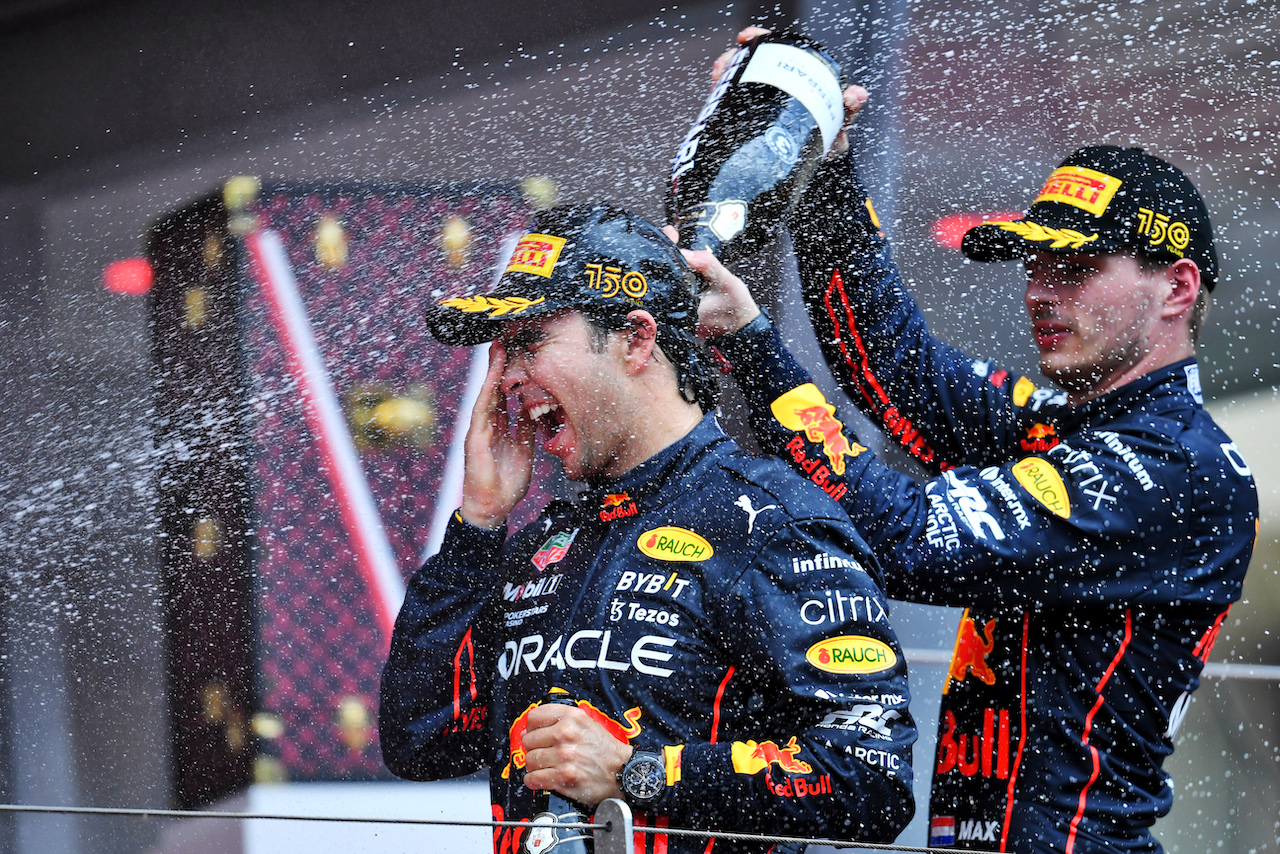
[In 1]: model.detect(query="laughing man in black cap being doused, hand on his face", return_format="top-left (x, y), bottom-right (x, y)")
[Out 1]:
top-left (379, 206), bottom-right (915, 854)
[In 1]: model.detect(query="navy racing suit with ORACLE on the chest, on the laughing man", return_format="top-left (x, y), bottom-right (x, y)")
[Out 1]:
top-left (379, 416), bottom-right (915, 854)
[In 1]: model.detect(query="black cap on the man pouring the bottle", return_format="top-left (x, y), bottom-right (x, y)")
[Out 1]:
top-left (960, 146), bottom-right (1217, 291)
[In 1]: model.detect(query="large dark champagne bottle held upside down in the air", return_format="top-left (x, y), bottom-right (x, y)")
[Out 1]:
top-left (667, 31), bottom-right (845, 264)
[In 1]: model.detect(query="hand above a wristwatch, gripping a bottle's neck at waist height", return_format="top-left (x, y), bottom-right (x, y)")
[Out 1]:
top-left (524, 704), bottom-right (631, 807)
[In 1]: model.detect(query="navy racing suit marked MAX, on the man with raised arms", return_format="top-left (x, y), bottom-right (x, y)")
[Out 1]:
top-left (718, 157), bottom-right (1258, 853)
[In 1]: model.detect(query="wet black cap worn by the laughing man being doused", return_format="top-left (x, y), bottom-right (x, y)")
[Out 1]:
top-left (426, 204), bottom-right (698, 346)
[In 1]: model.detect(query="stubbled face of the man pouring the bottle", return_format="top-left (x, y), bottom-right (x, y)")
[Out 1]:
top-left (1027, 252), bottom-right (1170, 398)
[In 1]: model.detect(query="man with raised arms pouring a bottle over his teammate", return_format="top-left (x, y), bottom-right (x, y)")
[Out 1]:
top-left (686, 33), bottom-right (1258, 854)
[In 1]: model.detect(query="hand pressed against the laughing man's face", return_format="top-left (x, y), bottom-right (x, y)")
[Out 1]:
top-left (460, 341), bottom-right (535, 529)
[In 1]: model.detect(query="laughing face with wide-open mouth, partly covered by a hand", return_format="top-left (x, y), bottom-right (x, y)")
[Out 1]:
top-left (498, 312), bottom-right (634, 480)
